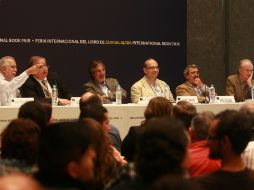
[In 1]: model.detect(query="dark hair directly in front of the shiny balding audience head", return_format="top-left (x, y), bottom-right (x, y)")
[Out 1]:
top-left (79, 104), bottom-right (108, 124)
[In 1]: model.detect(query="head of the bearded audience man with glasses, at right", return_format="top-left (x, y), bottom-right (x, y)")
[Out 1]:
top-left (208, 110), bottom-right (252, 160)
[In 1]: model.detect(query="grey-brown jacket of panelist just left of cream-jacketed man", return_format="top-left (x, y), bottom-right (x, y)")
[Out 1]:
top-left (83, 78), bottom-right (127, 103)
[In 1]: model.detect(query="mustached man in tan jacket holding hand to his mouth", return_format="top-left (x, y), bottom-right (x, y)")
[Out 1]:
top-left (176, 64), bottom-right (209, 103)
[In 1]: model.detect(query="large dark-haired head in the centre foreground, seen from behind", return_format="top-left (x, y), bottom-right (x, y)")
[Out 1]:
top-left (136, 117), bottom-right (188, 182)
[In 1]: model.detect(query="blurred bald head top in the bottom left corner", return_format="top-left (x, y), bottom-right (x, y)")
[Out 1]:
top-left (0, 173), bottom-right (42, 190)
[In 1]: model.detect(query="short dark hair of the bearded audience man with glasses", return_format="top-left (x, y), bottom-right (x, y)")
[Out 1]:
top-left (215, 110), bottom-right (252, 154)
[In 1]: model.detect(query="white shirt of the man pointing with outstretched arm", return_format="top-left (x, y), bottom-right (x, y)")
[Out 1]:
top-left (0, 71), bottom-right (28, 106)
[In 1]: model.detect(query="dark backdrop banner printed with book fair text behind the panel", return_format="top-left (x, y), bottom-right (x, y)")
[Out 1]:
top-left (0, 0), bottom-right (186, 101)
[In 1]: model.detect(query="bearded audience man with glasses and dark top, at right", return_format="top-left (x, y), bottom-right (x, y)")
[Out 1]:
top-left (193, 110), bottom-right (254, 190)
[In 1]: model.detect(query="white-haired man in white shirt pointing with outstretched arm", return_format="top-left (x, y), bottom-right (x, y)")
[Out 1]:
top-left (0, 56), bottom-right (41, 106)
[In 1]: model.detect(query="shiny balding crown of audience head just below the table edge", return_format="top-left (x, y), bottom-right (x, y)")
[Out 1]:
top-left (79, 92), bottom-right (102, 111)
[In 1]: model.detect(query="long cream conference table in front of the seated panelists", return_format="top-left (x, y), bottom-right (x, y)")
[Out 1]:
top-left (0, 103), bottom-right (242, 139)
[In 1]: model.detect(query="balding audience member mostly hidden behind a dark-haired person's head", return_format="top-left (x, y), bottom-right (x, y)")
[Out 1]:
top-left (79, 92), bottom-right (122, 152)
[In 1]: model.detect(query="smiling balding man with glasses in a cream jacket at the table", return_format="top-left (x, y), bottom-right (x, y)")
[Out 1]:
top-left (131, 58), bottom-right (175, 103)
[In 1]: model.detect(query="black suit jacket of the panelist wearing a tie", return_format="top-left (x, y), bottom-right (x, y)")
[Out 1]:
top-left (20, 73), bottom-right (71, 102)
